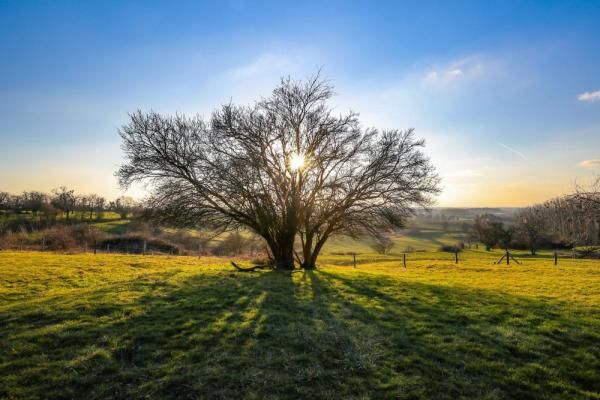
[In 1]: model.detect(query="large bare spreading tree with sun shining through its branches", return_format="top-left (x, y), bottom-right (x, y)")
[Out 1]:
top-left (117, 75), bottom-right (439, 269)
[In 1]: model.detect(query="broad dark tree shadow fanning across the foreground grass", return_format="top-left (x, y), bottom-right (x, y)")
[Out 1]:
top-left (0, 270), bottom-right (600, 399)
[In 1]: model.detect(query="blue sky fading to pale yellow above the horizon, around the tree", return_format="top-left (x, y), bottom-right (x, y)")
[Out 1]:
top-left (0, 0), bottom-right (600, 207)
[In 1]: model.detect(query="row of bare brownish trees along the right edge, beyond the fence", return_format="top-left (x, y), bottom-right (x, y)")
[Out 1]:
top-left (473, 178), bottom-right (600, 254)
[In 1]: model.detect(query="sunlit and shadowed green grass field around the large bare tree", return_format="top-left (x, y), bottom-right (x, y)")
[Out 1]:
top-left (0, 251), bottom-right (600, 399)
